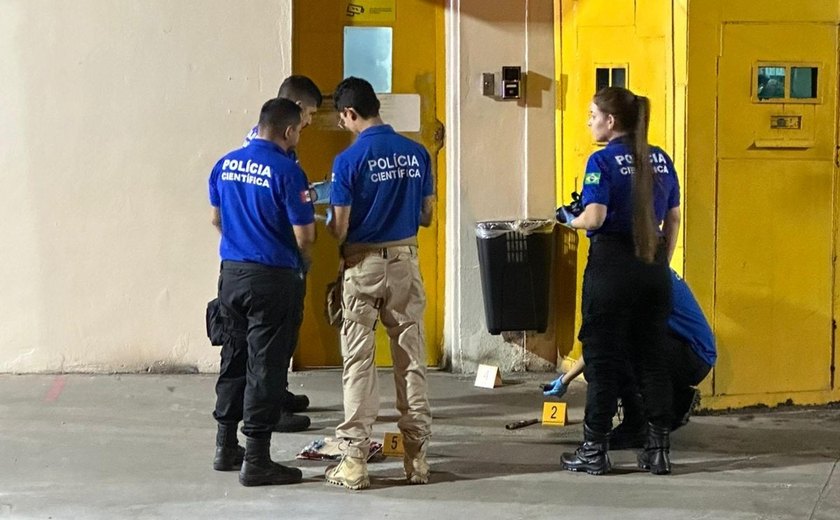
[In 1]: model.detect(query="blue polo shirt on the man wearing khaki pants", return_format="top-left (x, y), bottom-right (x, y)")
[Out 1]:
top-left (330, 125), bottom-right (434, 243)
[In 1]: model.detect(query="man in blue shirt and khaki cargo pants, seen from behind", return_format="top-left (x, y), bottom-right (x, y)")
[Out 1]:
top-left (326, 78), bottom-right (434, 489)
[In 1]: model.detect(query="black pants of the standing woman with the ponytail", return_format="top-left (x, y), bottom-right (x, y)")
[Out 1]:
top-left (578, 235), bottom-right (673, 433)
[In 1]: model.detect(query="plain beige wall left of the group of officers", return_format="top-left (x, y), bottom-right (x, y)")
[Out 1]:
top-left (0, 0), bottom-right (291, 372)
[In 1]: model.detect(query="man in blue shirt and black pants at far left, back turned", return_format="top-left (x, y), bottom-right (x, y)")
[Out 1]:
top-left (209, 98), bottom-right (315, 486)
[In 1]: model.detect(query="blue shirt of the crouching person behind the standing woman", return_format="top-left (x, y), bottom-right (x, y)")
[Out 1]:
top-left (668, 269), bottom-right (717, 366)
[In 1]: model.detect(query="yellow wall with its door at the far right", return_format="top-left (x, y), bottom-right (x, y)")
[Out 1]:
top-left (685, 0), bottom-right (840, 408)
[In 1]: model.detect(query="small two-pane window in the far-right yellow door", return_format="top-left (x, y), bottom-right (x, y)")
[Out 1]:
top-left (753, 63), bottom-right (821, 103)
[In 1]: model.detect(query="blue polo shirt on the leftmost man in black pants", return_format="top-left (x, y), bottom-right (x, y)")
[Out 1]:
top-left (209, 139), bottom-right (315, 269)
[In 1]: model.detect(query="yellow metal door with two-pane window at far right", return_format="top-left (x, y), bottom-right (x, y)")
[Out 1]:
top-left (716, 23), bottom-right (837, 395)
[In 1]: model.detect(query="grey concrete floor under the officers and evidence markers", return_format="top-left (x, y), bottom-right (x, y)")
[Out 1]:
top-left (0, 370), bottom-right (840, 520)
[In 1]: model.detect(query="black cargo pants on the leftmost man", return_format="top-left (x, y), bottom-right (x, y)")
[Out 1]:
top-left (213, 261), bottom-right (305, 438)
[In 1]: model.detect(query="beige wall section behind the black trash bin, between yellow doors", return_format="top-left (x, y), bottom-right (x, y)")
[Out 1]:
top-left (445, 0), bottom-right (556, 372)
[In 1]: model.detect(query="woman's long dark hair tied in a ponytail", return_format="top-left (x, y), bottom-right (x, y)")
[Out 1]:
top-left (593, 87), bottom-right (659, 262)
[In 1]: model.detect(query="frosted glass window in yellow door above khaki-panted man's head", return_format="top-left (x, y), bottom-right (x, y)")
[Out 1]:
top-left (344, 27), bottom-right (394, 94)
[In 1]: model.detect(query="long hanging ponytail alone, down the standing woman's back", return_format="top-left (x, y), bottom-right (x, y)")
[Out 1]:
top-left (633, 96), bottom-right (658, 262)
